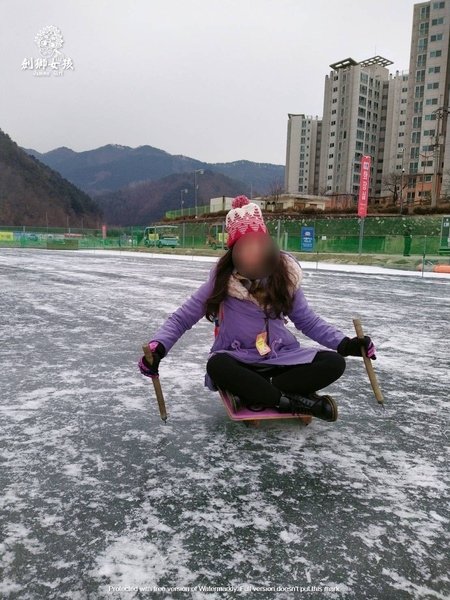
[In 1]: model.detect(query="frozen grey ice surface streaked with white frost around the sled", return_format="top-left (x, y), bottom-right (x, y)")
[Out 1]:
top-left (0, 249), bottom-right (450, 600)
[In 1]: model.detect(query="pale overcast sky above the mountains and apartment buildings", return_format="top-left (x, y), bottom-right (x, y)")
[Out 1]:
top-left (0, 0), bottom-right (420, 164)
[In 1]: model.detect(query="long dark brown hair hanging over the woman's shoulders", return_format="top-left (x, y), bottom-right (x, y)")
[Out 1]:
top-left (205, 248), bottom-right (294, 321)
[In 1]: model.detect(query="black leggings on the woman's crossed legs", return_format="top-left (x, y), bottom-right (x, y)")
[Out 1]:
top-left (206, 350), bottom-right (346, 407)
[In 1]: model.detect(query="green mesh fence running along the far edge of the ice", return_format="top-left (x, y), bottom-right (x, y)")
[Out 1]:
top-left (0, 215), bottom-right (450, 264)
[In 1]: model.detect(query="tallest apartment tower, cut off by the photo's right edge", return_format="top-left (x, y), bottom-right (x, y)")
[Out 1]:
top-left (405, 0), bottom-right (450, 201)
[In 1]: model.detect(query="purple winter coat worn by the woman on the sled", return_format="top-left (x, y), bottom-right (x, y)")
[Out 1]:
top-left (151, 250), bottom-right (346, 391)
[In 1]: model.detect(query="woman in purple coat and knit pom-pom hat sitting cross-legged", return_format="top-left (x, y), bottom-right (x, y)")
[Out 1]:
top-left (138, 196), bottom-right (376, 421)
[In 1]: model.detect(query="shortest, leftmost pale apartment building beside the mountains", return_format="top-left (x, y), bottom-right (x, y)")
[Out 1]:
top-left (284, 114), bottom-right (322, 194)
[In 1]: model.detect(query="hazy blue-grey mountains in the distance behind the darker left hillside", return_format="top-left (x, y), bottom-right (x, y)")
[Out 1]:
top-left (19, 144), bottom-right (284, 226)
